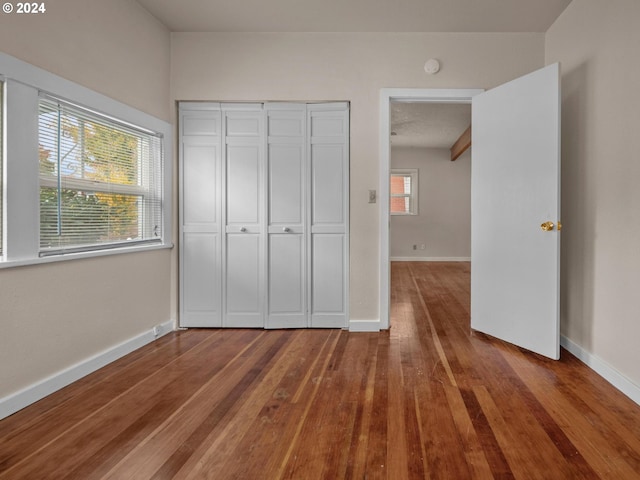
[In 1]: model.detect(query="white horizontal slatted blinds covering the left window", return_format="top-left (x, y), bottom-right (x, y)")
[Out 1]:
top-left (38, 95), bottom-right (163, 256)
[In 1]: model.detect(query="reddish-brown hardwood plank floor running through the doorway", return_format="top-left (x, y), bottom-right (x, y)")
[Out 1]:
top-left (0, 263), bottom-right (640, 480)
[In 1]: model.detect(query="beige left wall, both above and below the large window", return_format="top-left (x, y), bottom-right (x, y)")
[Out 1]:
top-left (0, 0), bottom-right (173, 398)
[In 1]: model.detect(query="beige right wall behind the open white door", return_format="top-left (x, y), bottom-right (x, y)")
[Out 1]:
top-left (545, 0), bottom-right (640, 385)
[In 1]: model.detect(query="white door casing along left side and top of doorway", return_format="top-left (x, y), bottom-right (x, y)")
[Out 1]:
top-left (379, 88), bottom-right (484, 329)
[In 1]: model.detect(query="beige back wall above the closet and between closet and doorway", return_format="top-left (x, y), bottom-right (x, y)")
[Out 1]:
top-left (171, 33), bottom-right (544, 320)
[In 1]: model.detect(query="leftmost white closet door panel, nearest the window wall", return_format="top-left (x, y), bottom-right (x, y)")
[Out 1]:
top-left (179, 103), bottom-right (222, 327)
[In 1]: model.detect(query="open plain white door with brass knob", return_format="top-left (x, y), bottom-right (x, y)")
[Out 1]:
top-left (471, 64), bottom-right (560, 359)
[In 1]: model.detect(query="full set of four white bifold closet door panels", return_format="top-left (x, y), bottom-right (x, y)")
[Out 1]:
top-left (180, 102), bottom-right (349, 328)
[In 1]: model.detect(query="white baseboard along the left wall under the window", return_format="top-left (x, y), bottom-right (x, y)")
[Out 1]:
top-left (0, 320), bottom-right (175, 419)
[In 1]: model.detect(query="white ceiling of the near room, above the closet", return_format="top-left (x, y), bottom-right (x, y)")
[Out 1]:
top-left (137, 0), bottom-right (571, 32)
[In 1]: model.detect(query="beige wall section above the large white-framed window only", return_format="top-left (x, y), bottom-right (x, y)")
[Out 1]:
top-left (0, 0), bottom-right (171, 121)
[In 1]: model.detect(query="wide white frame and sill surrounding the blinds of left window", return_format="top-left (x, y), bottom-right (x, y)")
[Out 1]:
top-left (0, 52), bottom-right (173, 268)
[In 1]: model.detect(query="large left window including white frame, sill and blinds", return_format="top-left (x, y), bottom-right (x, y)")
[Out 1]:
top-left (0, 52), bottom-right (173, 269)
